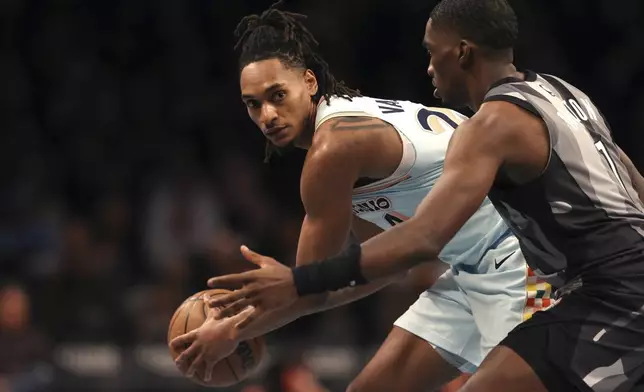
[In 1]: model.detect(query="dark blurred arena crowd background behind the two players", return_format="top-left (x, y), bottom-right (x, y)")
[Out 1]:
top-left (0, 0), bottom-right (644, 392)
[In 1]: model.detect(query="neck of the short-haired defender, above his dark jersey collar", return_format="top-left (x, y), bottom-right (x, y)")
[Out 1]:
top-left (467, 59), bottom-right (524, 112)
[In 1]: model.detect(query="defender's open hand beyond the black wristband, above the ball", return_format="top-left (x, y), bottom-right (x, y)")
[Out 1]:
top-left (208, 246), bottom-right (298, 329)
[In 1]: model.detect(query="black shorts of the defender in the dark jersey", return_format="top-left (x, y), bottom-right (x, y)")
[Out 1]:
top-left (500, 254), bottom-right (644, 392)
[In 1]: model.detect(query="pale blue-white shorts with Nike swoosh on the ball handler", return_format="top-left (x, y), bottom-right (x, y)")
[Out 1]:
top-left (394, 235), bottom-right (552, 373)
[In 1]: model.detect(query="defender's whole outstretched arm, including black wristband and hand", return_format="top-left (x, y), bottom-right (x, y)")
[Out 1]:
top-left (210, 102), bottom-right (532, 309)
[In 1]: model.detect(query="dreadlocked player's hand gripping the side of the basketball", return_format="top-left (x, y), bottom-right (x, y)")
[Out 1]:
top-left (170, 309), bottom-right (252, 383)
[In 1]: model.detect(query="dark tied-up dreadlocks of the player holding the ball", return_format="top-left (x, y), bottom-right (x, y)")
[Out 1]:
top-left (235, 0), bottom-right (360, 162)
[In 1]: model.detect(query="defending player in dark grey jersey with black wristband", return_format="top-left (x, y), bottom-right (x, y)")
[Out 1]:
top-left (205, 0), bottom-right (644, 392)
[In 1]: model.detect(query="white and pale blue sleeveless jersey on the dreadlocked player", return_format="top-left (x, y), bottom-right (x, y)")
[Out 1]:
top-left (315, 97), bottom-right (510, 265)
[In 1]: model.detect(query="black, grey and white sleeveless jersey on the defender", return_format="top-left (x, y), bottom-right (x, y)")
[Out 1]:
top-left (485, 72), bottom-right (644, 285)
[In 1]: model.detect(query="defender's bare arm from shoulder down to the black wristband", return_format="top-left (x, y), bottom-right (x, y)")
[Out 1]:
top-left (352, 102), bottom-right (528, 280)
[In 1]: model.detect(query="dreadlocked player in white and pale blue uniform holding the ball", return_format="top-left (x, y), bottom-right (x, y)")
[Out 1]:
top-left (173, 2), bottom-right (550, 392)
